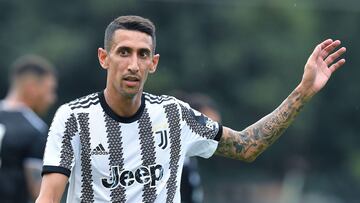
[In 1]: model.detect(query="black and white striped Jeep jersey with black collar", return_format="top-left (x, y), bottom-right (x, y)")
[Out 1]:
top-left (43, 92), bottom-right (222, 203)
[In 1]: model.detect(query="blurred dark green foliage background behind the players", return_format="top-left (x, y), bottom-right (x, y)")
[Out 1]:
top-left (0, 0), bottom-right (360, 203)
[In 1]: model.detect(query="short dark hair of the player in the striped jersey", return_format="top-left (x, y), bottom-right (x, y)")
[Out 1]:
top-left (104, 15), bottom-right (156, 52)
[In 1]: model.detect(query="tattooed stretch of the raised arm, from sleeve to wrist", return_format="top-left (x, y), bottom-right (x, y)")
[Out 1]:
top-left (216, 90), bottom-right (307, 161)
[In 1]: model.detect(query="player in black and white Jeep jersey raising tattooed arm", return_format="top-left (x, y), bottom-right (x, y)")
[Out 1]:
top-left (37, 16), bottom-right (345, 203)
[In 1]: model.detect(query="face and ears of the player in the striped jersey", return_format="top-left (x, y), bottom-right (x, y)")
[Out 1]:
top-left (98, 29), bottom-right (160, 98)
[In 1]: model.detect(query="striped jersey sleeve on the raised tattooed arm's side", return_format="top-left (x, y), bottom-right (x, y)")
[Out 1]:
top-left (180, 103), bottom-right (222, 158)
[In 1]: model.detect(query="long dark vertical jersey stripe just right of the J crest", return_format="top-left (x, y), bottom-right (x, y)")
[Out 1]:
top-left (164, 104), bottom-right (181, 203)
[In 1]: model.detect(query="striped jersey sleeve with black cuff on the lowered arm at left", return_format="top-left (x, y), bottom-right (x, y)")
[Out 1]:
top-left (42, 105), bottom-right (78, 177)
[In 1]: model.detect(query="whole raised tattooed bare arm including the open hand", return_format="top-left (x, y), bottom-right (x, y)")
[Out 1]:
top-left (216, 39), bottom-right (346, 162)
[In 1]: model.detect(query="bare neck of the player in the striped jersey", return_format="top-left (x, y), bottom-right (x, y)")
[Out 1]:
top-left (104, 88), bottom-right (142, 117)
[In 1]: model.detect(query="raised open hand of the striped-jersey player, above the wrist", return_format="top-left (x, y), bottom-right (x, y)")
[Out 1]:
top-left (300, 39), bottom-right (346, 97)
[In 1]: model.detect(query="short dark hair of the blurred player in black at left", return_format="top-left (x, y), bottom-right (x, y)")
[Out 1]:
top-left (10, 55), bottom-right (55, 82)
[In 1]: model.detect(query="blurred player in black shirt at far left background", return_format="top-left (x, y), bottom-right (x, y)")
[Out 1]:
top-left (0, 56), bottom-right (57, 203)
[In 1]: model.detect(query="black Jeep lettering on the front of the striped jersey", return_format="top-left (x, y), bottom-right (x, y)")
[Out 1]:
top-left (101, 164), bottom-right (164, 189)
